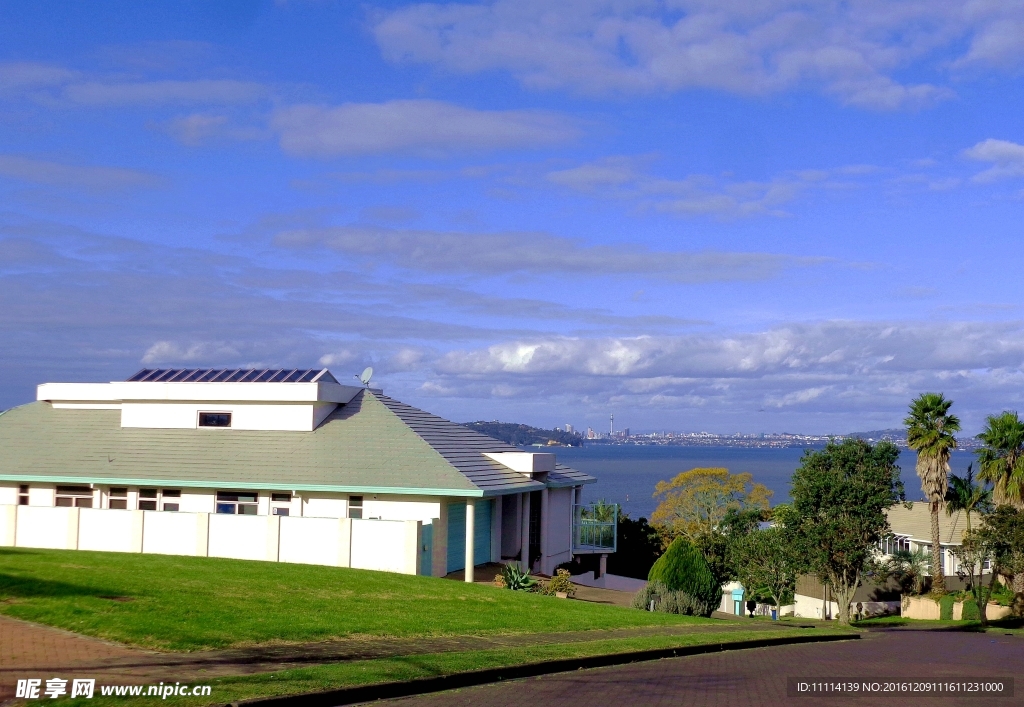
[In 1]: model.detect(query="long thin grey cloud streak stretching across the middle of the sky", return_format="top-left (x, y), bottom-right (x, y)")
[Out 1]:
top-left (274, 225), bottom-right (823, 283)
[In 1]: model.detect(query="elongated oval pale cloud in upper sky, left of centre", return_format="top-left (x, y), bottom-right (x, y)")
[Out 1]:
top-left (271, 100), bottom-right (578, 157)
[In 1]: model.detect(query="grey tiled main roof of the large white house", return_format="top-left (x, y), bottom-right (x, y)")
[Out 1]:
top-left (0, 389), bottom-right (595, 496)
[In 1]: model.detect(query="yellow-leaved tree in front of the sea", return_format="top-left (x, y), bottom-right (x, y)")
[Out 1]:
top-left (650, 468), bottom-right (773, 541)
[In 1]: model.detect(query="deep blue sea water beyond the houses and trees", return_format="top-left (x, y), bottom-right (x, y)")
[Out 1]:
top-left (548, 445), bottom-right (975, 518)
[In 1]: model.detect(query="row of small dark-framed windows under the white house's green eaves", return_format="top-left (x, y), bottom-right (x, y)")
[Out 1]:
top-left (17, 484), bottom-right (362, 518)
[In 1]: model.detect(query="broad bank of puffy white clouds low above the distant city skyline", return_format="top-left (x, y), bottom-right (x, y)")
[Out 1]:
top-left (423, 322), bottom-right (1024, 424)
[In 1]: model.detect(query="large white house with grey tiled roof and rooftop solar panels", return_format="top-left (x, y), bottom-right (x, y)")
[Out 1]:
top-left (0, 369), bottom-right (614, 581)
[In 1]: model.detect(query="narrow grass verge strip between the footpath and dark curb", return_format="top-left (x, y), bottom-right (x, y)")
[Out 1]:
top-left (70, 629), bottom-right (849, 707)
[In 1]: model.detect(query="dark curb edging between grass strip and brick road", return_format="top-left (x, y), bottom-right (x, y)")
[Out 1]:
top-left (230, 633), bottom-right (860, 707)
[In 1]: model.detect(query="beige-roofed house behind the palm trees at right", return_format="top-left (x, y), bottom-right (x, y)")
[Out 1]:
top-left (796, 502), bottom-right (987, 619)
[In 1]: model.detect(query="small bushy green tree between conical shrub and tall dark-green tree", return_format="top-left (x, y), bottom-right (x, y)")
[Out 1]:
top-left (730, 527), bottom-right (801, 607)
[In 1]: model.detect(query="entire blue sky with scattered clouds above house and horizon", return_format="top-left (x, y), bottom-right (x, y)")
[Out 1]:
top-left (0, 0), bottom-right (1024, 432)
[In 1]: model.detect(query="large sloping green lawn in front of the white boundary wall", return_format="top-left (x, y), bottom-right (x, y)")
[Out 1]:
top-left (0, 548), bottom-right (714, 651)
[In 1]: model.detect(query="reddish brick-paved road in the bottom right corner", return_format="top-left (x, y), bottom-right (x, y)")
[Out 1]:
top-left (393, 631), bottom-right (1024, 707)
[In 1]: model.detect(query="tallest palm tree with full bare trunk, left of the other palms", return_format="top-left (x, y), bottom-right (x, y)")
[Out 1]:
top-left (903, 392), bottom-right (959, 591)
